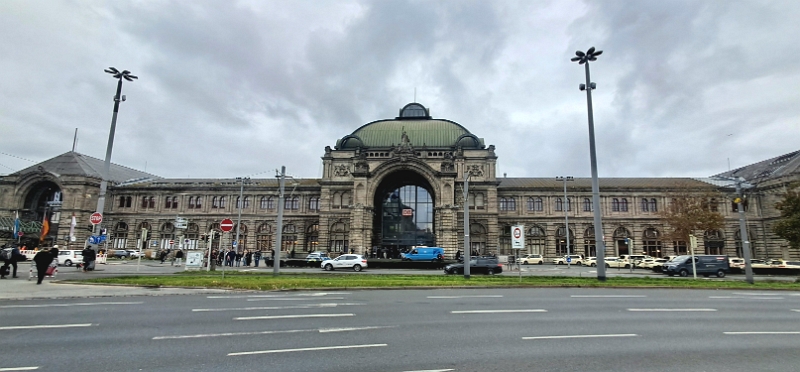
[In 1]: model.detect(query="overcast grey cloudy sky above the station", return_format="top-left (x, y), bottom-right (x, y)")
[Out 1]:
top-left (0, 0), bottom-right (800, 178)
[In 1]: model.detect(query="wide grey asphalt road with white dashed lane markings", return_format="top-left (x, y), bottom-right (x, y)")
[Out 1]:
top-left (0, 283), bottom-right (800, 372)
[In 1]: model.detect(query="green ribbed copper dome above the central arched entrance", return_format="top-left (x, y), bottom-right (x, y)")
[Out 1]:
top-left (336, 103), bottom-right (485, 150)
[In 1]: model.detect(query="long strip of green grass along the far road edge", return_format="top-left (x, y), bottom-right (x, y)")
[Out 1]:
top-left (70, 272), bottom-right (800, 290)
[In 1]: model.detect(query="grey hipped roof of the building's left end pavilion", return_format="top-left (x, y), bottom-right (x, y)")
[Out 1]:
top-left (11, 151), bottom-right (161, 183)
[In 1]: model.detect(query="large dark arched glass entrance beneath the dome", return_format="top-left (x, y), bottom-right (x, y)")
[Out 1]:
top-left (372, 170), bottom-right (436, 257)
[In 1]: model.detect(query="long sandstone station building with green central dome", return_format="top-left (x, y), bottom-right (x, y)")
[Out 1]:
top-left (0, 103), bottom-right (800, 259)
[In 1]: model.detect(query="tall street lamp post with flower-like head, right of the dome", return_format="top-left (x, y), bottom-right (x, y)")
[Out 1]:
top-left (571, 47), bottom-right (606, 282)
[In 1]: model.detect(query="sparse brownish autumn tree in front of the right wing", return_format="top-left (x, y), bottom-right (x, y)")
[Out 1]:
top-left (659, 184), bottom-right (725, 242)
